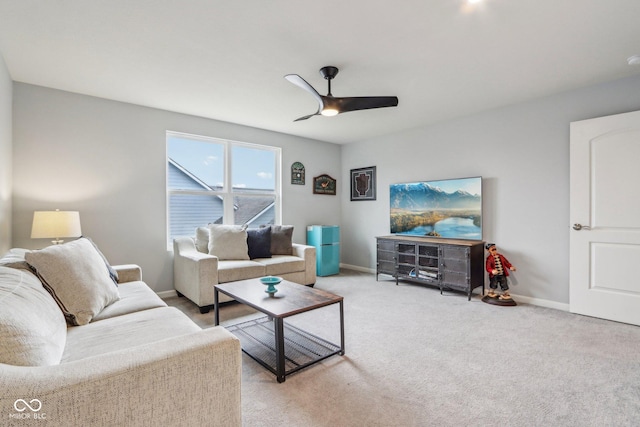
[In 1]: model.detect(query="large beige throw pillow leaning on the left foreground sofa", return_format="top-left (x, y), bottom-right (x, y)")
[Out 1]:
top-left (25, 237), bottom-right (120, 325)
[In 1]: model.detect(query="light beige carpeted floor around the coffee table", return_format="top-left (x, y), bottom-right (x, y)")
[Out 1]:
top-left (167, 270), bottom-right (640, 427)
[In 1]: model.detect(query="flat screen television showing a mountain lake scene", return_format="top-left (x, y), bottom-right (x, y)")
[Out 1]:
top-left (389, 177), bottom-right (482, 240)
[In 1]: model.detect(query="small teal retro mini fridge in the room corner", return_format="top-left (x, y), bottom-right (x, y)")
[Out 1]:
top-left (307, 225), bottom-right (340, 276)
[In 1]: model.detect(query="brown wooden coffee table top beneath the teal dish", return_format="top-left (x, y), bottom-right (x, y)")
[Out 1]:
top-left (215, 279), bottom-right (343, 317)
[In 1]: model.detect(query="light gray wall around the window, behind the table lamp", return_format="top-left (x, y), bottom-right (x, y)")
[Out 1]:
top-left (13, 83), bottom-right (341, 292)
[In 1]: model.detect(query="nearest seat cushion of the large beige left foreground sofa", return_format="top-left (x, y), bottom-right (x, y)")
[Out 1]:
top-left (61, 307), bottom-right (202, 363)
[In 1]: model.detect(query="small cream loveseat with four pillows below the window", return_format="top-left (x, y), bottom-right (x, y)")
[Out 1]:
top-left (173, 225), bottom-right (316, 313)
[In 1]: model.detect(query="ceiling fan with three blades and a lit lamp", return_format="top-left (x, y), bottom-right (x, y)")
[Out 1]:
top-left (284, 66), bottom-right (398, 122)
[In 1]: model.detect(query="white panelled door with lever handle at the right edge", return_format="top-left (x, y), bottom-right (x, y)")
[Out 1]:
top-left (568, 111), bottom-right (640, 325)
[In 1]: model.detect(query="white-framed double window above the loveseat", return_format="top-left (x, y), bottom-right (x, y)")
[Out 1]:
top-left (167, 132), bottom-right (281, 248)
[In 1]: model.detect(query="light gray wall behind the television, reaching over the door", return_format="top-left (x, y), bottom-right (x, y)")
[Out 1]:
top-left (341, 76), bottom-right (640, 304)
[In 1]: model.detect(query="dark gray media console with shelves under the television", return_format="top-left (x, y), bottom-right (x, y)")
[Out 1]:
top-left (376, 235), bottom-right (485, 300)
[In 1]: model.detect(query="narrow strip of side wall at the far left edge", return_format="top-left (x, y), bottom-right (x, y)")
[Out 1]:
top-left (0, 53), bottom-right (13, 254)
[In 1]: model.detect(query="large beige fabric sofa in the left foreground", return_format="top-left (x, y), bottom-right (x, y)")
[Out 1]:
top-left (0, 239), bottom-right (241, 426)
